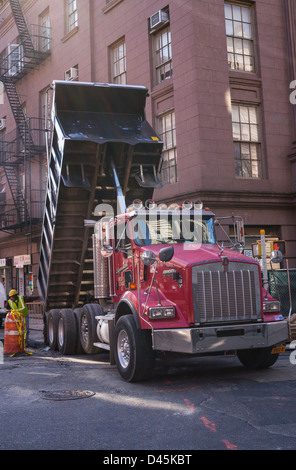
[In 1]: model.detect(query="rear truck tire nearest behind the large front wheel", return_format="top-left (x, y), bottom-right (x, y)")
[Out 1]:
top-left (79, 304), bottom-right (104, 354)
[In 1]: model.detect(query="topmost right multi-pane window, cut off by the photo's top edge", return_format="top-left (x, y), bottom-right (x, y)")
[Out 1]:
top-left (224, 3), bottom-right (255, 72)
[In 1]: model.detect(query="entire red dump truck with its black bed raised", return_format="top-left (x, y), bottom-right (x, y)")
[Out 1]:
top-left (38, 81), bottom-right (288, 382)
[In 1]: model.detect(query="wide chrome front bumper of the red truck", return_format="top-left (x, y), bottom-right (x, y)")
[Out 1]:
top-left (152, 321), bottom-right (289, 354)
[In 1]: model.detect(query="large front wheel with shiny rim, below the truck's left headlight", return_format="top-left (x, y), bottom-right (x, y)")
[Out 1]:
top-left (114, 315), bottom-right (154, 382)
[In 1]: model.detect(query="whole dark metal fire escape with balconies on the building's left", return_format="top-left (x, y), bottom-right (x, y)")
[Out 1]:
top-left (0, 0), bottom-right (50, 231)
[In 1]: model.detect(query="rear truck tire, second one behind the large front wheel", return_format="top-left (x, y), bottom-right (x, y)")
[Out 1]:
top-left (58, 308), bottom-right (78, 355)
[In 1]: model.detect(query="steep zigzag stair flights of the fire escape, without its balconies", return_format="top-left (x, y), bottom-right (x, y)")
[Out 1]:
top-left (0, 0), bottom-right (50, 228)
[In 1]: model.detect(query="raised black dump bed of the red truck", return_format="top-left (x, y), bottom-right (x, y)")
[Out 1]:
top-left (38, 81), bottom-right (162, 311)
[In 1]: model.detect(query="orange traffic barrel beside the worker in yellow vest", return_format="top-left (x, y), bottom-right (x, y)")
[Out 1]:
top-left (4, 311), bottom-right (25, 355)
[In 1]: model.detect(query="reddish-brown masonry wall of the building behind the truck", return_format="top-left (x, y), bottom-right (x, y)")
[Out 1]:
top-left (0, 0), bottom-right (296, 286)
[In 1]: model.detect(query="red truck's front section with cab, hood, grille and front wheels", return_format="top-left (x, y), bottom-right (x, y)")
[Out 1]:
top-left (95, 202), bottom-right (287, 381)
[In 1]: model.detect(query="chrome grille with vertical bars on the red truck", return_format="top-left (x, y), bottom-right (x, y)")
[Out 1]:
top-left (192, 262), bottom-right (261, 323)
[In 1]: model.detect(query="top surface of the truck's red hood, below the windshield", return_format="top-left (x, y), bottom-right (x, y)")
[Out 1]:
top-left (141, 243), bottom-right (258, 268)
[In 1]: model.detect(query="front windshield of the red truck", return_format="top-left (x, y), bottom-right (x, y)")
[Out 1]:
top-left (133, 213), bottom-right (216, 245)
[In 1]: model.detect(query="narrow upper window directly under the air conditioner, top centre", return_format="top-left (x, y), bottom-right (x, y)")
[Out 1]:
top-left (153, 26), bottom-right (173, 85)
